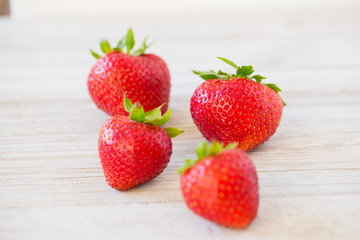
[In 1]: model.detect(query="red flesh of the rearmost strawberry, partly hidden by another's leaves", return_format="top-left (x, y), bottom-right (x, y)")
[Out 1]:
top-left (87, 52), bottom-right (170, 116)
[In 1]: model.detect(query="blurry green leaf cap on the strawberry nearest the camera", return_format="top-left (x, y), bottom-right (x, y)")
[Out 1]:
top-left (178, 141), bottom-right (238, 175)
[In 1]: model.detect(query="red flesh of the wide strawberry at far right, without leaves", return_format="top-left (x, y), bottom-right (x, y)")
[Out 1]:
top-left (190, 78), bottom-right (283, 151)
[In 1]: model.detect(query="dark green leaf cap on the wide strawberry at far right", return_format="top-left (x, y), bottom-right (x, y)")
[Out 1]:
top-left (193, 57), bottom-right (286, 106)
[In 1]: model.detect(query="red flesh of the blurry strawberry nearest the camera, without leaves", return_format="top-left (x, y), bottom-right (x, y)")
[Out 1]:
top-left (180, 149), bottom-right (259, 229)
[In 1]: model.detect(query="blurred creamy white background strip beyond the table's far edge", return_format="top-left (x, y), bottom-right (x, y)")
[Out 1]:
top-left (7, 0), bottom-right (359, 19)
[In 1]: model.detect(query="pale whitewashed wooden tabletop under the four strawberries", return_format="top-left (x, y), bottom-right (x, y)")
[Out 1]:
top-left (0, 3), bottom-right (360, 240)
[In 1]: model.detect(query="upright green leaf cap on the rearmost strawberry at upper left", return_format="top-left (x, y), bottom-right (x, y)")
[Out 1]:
top-left (90, 28), bottom-right (150, 59)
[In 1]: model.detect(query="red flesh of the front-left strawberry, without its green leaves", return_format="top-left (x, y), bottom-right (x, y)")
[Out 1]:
top-left (98, 116), bottom-right (172, 191)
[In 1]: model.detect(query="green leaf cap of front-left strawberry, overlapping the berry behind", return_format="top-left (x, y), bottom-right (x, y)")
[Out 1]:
top-left (124, 95), bottom-right (184, 138)
